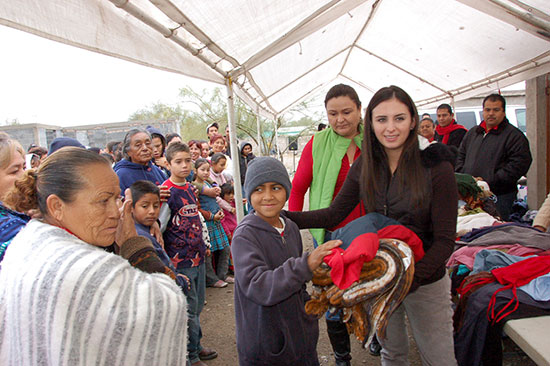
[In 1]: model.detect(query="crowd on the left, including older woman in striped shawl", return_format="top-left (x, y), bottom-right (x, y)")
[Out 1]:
top-left (0, 124), bottom-right (254, 365)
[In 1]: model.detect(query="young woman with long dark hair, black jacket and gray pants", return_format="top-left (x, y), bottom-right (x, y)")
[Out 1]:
top-left (289, 86), bottom-right (458, 366)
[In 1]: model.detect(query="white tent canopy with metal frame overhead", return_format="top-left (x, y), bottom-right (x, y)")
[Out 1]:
top-left (0, 0), bottom-right (550, 118)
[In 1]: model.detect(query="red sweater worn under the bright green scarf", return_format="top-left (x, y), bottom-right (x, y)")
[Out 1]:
top-left (288, 136), bottom-right (365, 230)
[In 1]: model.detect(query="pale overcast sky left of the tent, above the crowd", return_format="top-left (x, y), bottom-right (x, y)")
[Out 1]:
top-left (0, 25), bottom-right (220, 126)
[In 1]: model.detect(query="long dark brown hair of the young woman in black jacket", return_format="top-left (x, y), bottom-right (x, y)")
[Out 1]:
top-left (361, 85), bottom-right (428, 212)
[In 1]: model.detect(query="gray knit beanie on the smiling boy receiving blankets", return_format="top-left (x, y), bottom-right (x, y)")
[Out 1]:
top-left (244, 156), bottom-right (292, 202)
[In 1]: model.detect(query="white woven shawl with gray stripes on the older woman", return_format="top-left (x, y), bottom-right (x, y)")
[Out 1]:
top-left (0, 220), bottom-right (187, 366)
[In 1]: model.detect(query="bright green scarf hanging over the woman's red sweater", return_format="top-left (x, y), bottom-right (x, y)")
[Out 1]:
top-left (309, 123), bottom-right (363, 244)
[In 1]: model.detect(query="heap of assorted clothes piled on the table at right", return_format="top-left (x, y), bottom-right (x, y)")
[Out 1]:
top-left (447, 176), bottom-right (550, 366)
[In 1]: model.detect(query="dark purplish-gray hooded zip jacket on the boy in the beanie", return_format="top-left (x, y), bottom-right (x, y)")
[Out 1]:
top-left (231, 212), bottom-right (319, 366)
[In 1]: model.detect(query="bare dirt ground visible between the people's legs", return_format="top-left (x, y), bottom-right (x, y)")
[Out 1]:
top-left (201, 230), bottom-right (536, 366)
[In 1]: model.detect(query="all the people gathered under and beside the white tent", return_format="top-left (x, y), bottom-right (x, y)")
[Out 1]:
top-left (0, 84), bottom-right (550, 366)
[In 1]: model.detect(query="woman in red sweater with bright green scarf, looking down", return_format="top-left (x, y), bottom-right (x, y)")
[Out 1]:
top-left (288, 84), bottom-right (365, 366)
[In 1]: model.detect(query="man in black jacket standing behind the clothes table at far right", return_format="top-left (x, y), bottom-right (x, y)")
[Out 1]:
top-left (456, 94), bottom-right (533, 220)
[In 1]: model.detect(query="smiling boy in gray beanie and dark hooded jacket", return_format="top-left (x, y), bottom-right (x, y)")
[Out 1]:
top-left (231, 157), bottom-right (341, 366)
